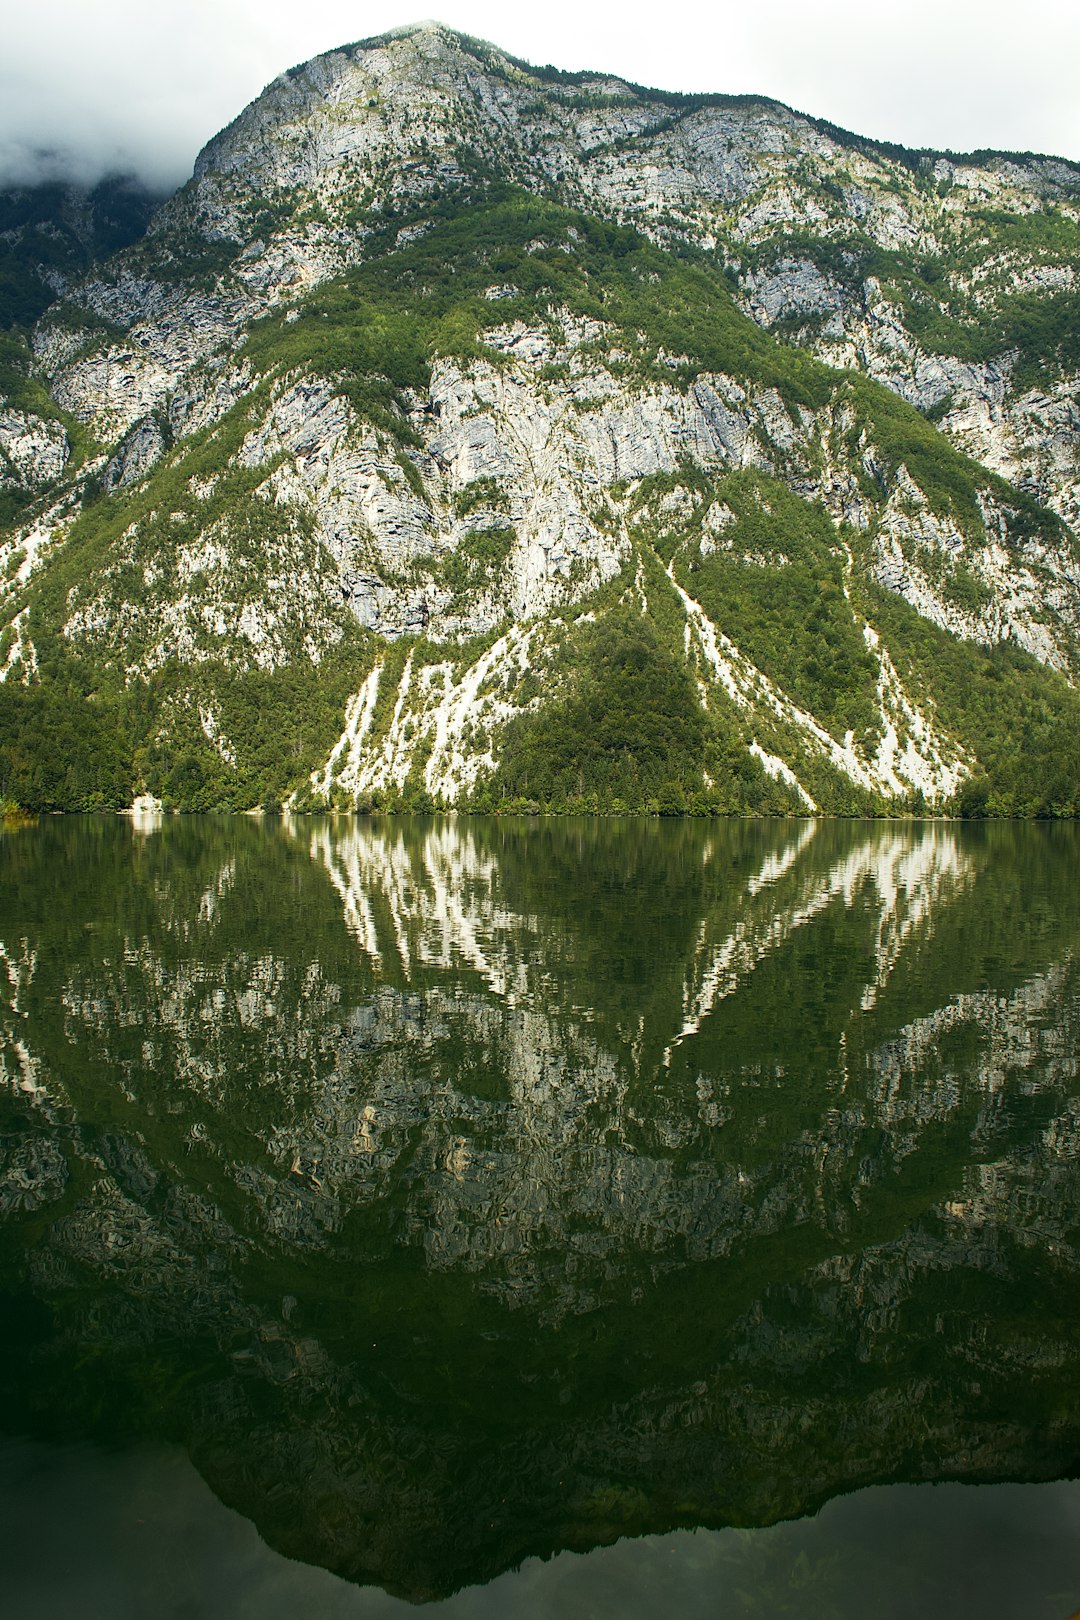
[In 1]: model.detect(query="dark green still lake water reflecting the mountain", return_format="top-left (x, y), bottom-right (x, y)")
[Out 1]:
top-left (0, 818), bottom-right (1080, 1620)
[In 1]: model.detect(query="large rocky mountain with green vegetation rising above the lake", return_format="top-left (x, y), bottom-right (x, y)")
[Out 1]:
top-left (0, 24), bottom-right (1080, 815)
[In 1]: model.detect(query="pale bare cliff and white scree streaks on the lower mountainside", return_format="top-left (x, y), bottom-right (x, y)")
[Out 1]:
top-left (33, 277), bottom-right (1074, 808)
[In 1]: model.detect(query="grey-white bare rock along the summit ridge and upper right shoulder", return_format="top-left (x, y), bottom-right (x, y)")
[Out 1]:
top-left (27, 24), bottom-right (1080, 567)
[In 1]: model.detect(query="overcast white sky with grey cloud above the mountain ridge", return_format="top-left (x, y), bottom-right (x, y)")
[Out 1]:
top-left (0, 0), bottom-right (1080, 185)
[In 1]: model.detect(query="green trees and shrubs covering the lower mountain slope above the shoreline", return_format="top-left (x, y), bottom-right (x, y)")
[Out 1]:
top-left (0, 186), bottom-right (1080, 815)
